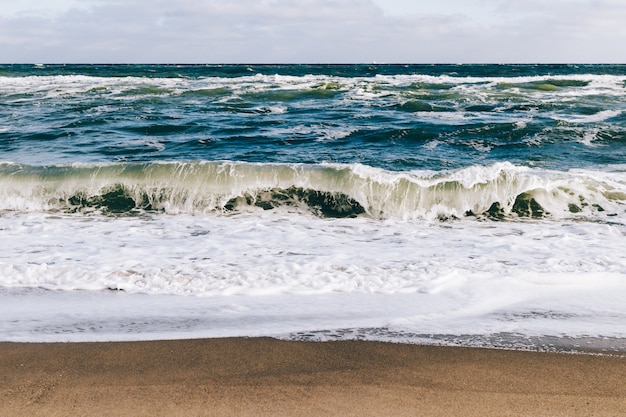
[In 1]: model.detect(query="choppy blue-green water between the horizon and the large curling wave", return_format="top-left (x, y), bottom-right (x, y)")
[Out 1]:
top-left (0, 65), bottom-right (626, 171)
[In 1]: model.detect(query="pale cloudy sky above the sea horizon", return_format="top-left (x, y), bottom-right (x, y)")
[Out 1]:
top-left (0, 0), bottom-right (626, 63)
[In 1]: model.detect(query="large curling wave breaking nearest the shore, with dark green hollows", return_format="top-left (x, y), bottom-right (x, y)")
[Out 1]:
top-left (0, 161), bottom-right (626, 220)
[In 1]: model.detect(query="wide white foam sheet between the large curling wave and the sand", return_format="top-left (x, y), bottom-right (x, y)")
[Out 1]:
top-left (0, 210), bottom-right (626, 340)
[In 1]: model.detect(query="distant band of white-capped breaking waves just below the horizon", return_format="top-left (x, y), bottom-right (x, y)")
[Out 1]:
top-left (0, 74), bottom-right (626, 101)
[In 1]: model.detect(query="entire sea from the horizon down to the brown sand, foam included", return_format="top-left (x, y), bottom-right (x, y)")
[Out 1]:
top-left (0, 64), bottom-right (626, 352)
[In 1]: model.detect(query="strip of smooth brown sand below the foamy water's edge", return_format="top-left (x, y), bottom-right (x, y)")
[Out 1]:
top-left (0, 339), bottom-right (626, 417)
